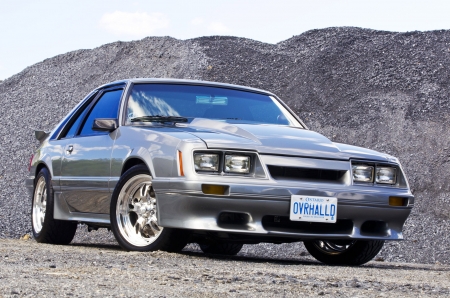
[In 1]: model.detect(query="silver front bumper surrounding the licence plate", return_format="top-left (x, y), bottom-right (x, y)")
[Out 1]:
top-left (153, 179), bottom-right (414, 241)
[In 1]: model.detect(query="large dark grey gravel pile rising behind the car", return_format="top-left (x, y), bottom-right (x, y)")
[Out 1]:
top-left (0, 27), bottom-right (450, 264)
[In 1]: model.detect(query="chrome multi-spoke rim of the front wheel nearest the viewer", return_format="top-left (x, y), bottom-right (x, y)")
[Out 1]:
top-left (116, 174), bottom-right (163, 247)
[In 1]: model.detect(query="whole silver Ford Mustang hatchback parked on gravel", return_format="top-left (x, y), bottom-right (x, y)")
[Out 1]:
top-left (26, 79), bottom-right (414, 265)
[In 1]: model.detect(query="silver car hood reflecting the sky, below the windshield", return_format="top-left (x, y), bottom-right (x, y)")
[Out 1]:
top-left (185, 118), bottom-right (395, 161)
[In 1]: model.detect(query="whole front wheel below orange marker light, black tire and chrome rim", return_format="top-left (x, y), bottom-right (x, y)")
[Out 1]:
top-left (110, 164), bottom-right (190, 252)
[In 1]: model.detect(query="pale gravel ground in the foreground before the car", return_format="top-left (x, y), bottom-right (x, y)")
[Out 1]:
top-left (0, 240), bottom-right (450, 297)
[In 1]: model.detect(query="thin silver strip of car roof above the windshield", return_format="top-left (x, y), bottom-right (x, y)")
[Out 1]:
top-left (97, 78), bottom-right (275, 96)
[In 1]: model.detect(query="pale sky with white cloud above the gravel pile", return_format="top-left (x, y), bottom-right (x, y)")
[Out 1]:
top-left (0, 0), bottom-right (450, 80)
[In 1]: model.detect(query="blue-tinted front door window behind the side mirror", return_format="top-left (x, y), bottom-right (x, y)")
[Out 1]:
top-left (80, 89), bottom-right (123, 136)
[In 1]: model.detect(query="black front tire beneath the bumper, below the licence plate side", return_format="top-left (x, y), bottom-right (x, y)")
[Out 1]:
top-left (304, 240), bottom-right (384, 266)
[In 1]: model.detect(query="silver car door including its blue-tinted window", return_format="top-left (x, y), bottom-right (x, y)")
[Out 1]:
top-left (60, 87), bottom-right (123, 214)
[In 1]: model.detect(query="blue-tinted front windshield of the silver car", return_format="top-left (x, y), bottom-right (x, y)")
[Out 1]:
top-left (126, 84), bottom-right (301, 127)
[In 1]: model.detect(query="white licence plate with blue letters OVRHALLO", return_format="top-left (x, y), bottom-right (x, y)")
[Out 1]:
top-left (289, 195), bottom-right (337, 223)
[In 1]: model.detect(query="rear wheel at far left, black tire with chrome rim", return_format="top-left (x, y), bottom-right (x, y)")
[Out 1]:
top-left (31, 168), bottom-right (77, 244)
